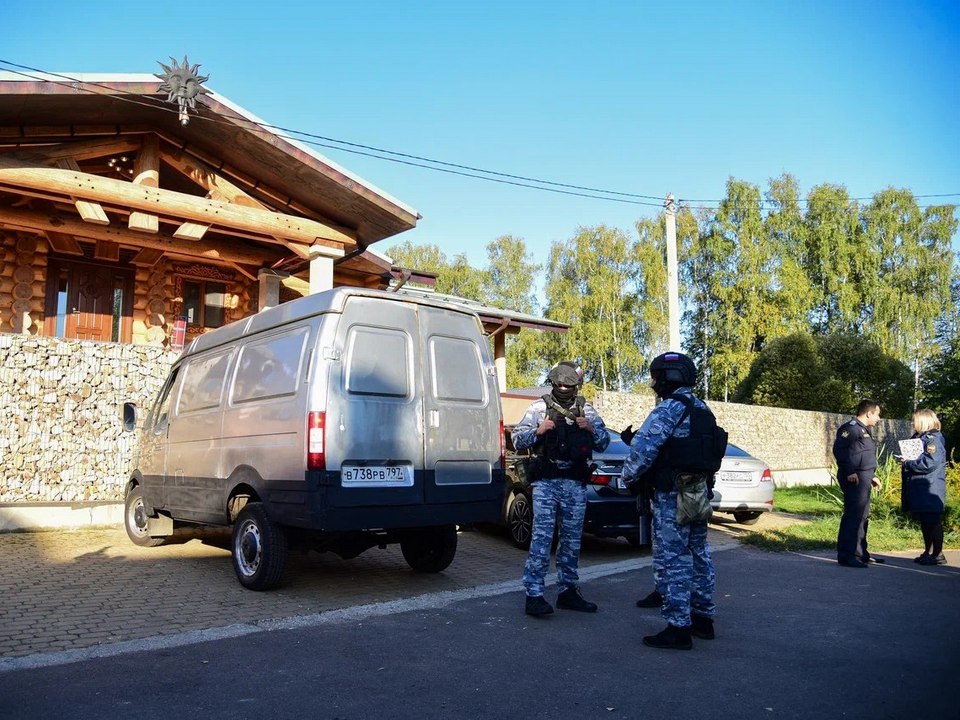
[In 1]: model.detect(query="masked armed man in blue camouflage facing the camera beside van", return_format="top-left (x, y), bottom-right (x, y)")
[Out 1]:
top-left (512, 362), bottom-right (610, 617)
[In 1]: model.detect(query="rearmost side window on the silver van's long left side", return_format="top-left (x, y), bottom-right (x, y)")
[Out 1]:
top-left (230, 327), bottom-right (309, 403)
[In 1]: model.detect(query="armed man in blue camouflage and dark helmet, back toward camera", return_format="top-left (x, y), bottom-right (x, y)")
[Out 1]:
top-left (623, 353), bottom-right (716, 650)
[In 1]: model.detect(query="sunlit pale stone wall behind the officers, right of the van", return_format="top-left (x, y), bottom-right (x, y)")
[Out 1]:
top-left (596, 392), bottom-right (913, 471)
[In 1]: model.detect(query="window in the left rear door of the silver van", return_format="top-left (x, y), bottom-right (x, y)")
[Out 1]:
top-left (344, 325), bottom-right (410, 397)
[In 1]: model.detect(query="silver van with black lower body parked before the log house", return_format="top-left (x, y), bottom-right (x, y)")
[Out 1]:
top-left (124, 288), bottom-right (504, 590)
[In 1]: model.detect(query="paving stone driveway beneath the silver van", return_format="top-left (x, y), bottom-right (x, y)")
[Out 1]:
top-left (0, 528), bottom-right (676, 658)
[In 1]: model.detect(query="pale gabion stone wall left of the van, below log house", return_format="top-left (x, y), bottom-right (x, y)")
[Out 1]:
top-left (0, 333), bottom-right (176, 503)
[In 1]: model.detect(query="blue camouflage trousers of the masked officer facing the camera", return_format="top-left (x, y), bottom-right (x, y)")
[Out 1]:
top-left (523, 478), bottom-right (587, 597)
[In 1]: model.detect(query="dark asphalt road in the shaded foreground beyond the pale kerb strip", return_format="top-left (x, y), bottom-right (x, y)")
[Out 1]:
top-left (0, 536), bottom-right (960, 720)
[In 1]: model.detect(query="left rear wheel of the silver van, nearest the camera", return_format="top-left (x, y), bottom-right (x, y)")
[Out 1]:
top-left (230, 502), bottom-right (287, 590)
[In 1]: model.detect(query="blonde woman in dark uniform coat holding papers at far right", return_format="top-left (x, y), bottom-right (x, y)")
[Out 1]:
top-left (900, 410), bottom-right (947, 565)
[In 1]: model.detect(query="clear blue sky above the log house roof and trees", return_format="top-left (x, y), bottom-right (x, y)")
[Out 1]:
top-left (0, 0), bottom-right (960, 266)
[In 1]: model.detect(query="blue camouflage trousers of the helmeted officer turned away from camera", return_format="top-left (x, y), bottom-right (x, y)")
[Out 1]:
top-left (653, 490), bottom-right (716, 627)
